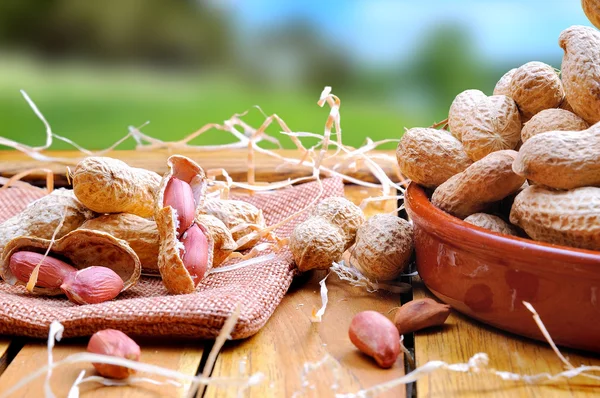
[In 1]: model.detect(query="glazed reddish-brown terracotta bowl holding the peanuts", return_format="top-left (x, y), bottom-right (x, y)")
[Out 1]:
top-left (405, 183), bottom-right (600, 352)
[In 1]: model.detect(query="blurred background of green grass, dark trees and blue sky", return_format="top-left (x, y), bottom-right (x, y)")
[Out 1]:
top-left (0, 0), bottom-right (589, 149)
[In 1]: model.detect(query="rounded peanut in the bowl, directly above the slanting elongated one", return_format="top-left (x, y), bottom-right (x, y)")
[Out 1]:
top-left (462, 95), bottom-right (521, 160)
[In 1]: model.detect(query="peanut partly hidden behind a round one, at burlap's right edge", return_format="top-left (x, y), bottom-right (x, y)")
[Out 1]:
top-left (311, 197), bottom-right (365, 251)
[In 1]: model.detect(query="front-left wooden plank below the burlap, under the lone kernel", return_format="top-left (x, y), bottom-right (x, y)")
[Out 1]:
top-left (0, 339), bottom-right (203, 398)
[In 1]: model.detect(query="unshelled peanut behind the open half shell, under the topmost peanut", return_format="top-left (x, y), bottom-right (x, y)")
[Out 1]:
top-left (80, 213), bottom-right (160, 275)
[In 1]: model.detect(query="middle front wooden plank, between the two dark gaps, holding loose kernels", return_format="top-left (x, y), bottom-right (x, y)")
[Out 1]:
top-left (206, 186), bottom-right (405, 398)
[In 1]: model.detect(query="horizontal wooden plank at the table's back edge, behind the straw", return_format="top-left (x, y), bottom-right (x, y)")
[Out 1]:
top-left (0, 149), bottom-right (398, 186)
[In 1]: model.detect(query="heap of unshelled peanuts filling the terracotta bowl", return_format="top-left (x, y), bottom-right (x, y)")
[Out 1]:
top-left (396, 20), bottom-right (600, 250)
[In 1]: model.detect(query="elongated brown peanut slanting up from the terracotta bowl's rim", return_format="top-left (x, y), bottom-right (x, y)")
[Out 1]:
top-left (431, 150), bottom-right (525, 219)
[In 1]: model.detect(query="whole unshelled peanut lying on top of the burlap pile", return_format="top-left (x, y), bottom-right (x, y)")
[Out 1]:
top-left (72, 156), bottom-right (160, 217)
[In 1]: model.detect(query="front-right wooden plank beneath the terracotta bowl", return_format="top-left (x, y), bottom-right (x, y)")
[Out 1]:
top-left (413, 281), bottom-right (600, 398)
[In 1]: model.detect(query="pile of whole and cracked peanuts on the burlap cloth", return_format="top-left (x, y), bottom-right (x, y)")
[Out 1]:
top-left (0, 155), bottom-right (266, 304)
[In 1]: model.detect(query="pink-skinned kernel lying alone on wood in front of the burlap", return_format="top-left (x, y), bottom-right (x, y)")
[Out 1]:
top-left (87, 329), bottom-right (141, 379)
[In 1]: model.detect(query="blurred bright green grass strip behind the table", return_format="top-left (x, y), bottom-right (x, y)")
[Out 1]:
top-left (0, 60), bottom-right (417, 149)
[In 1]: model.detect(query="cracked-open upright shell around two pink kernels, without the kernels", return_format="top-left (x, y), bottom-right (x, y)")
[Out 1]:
top-left (154, 155), bottom-right (214, 294)
